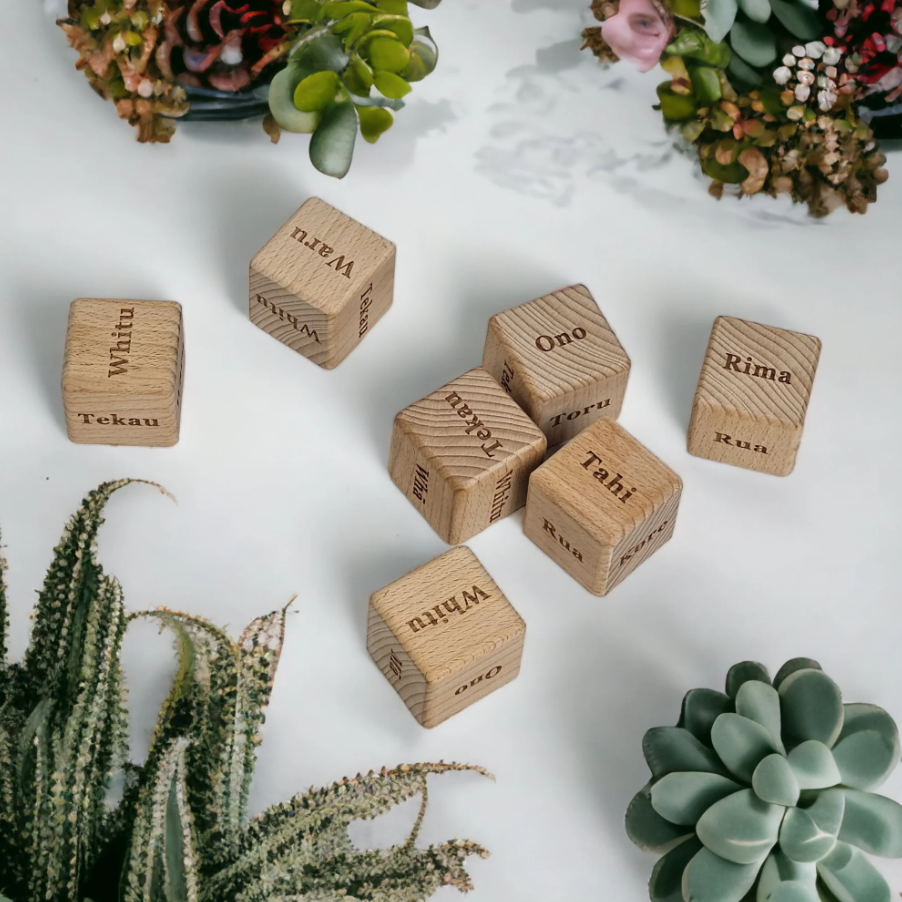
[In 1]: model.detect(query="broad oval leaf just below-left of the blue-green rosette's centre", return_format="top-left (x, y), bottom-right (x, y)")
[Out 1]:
top-left (695, 789), bottom-right (784, 864)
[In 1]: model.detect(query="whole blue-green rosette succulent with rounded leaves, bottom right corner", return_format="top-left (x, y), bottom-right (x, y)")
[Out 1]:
top-left (626, 658), bottom-right (902, 902)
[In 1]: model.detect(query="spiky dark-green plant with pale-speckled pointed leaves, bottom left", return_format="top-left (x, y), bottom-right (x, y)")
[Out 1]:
top-left (0, 480), bottom-right (488, 902)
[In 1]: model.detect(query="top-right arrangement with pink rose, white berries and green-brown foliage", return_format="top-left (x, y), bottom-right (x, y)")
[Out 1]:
top-left (583, 0), bottom-right (902, 216)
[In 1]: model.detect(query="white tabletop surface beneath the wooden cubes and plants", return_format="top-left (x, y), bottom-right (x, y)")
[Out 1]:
top-left (0, 0), bottom-right (902, 902)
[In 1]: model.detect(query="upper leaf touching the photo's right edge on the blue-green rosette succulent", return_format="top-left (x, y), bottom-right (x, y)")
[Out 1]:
top-left (833, 705), bottom-right (902, 789)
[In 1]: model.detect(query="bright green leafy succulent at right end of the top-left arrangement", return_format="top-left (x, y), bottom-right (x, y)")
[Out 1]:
top-left (269, 0), bottom-right (440, 178)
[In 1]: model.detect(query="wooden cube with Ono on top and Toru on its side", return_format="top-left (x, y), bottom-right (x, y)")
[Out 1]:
top-left (482, 285), bottom-right (630, 446)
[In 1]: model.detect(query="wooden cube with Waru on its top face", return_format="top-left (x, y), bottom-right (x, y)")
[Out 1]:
top-left (249, 197), bottom-right (395, 370)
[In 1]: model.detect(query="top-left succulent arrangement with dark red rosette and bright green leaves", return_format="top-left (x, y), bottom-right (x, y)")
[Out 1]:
top-left (59, 0), bottom-right (441, 178)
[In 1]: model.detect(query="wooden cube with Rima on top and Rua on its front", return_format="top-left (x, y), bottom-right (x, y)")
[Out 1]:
top-left (688, 316), bottom-right (821, 476)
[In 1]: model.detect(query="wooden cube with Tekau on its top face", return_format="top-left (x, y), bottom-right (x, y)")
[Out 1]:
top-left (389, 367), bottom-right (546, 545)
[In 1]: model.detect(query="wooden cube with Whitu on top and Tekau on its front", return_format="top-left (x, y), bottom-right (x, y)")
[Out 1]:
top-left (62, 298), bottom-right (185, 446)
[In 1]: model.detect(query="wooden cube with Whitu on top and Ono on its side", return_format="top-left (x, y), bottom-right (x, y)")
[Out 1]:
top-left (367, 546), bottom-right (526, 727)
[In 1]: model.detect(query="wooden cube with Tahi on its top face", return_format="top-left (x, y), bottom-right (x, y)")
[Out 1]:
top-left (523, 418), bottom-right (683, 595)
